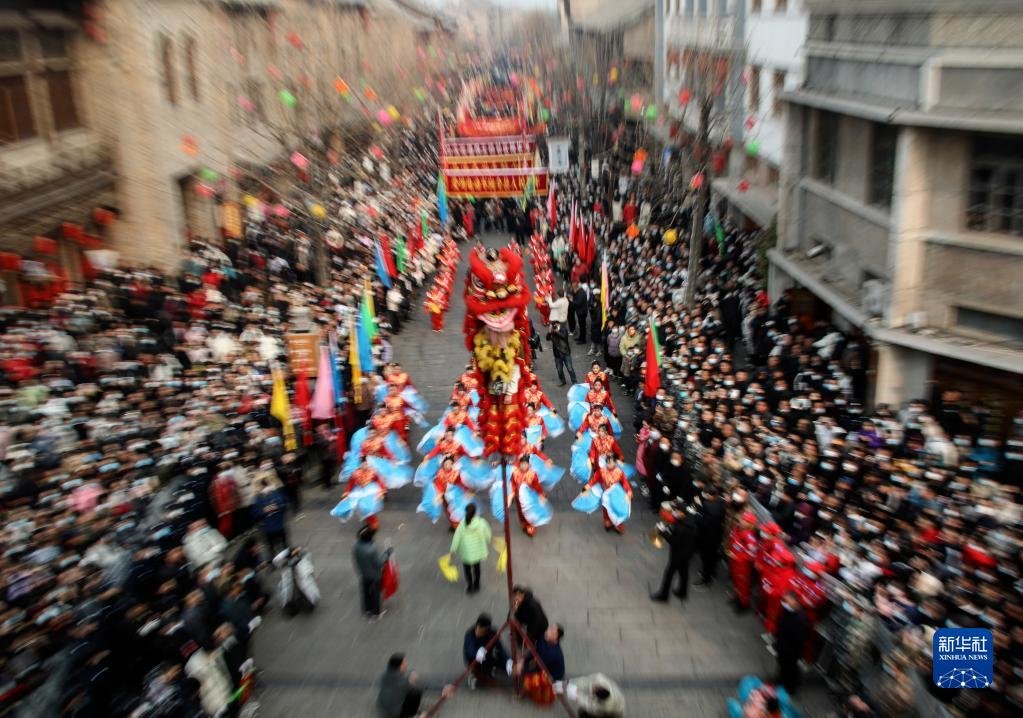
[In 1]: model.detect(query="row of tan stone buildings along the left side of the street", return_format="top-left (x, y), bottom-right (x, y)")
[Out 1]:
top-left (0, 0), bottom-right (453, 284)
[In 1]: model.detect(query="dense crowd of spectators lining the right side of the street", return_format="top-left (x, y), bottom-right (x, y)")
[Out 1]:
top-left (548, 163), bottom-right (1023, 716)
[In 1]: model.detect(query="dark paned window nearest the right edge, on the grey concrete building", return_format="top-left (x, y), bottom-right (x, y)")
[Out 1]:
top-left (966, 135), bottom-right (1023, 236)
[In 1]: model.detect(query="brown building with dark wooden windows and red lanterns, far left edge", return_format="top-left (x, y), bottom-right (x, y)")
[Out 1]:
top-left (0, 1), bottom-right (117, 303)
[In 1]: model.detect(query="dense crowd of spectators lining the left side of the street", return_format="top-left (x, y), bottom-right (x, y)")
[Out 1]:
top-left (0, 126), bottom-right (448, 718)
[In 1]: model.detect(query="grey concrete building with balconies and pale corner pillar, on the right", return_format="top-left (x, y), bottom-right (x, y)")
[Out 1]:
top-left (769, 0), bottom-right (1023, 416)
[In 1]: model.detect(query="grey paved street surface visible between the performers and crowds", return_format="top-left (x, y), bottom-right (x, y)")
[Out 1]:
top-left (256, 236), bottom-right (827, 718)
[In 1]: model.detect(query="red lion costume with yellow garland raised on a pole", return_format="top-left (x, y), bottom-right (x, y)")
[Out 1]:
top-left (464, 245), bottom-right (532, 456)
